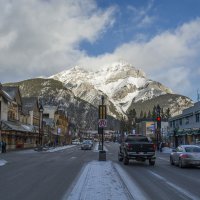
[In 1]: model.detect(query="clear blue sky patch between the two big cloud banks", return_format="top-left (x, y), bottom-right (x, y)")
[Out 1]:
top-left (80, 0), bottom-right (200, 56)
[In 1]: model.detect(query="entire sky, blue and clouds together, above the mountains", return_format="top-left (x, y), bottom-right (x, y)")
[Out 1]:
top-left (0, 0), bottom-right (200, 101)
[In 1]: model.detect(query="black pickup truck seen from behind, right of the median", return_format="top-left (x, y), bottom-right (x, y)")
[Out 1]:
top-left (118, 135), bottom-right (156, 165)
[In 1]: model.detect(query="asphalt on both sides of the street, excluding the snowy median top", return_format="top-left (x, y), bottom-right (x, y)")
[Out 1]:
top-left (0, 143), bottom-right (200, 200)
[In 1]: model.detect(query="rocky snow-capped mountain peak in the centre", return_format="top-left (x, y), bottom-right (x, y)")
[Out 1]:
top-left (49, 62), bottom-right (181, 116)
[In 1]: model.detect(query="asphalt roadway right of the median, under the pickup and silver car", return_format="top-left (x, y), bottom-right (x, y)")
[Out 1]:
top-left (106, 144), bottom-right (200, 200)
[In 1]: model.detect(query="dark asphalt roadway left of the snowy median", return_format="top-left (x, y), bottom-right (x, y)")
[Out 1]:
top-left (0, 147), bottom-right (98, 200)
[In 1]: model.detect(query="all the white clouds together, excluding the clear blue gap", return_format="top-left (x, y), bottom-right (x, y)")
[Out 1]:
top-left (0, 0), bottom-right (200, 100)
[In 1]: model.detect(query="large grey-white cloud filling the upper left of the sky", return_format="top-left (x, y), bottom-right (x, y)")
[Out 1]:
top-left (0, 0), bottom-right (115, 81)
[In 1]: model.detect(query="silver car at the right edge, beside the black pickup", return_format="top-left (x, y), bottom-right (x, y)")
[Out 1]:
top-left (170, 145), bottom-right (200, 168)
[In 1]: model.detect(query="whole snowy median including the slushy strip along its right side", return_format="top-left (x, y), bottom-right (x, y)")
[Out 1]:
top-left (62, 161), bottom-right (147, 200)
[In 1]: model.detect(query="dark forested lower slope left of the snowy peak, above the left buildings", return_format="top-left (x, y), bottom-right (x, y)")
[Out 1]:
top-left (5, 78), bottom-right (119, 129)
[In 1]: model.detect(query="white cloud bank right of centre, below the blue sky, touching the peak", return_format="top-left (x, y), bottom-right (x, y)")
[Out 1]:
top-left (77, 18), bottom-right (200, 99)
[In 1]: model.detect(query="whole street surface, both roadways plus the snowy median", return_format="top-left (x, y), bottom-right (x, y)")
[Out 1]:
top-left (0, 143), bottom-right (200, 200)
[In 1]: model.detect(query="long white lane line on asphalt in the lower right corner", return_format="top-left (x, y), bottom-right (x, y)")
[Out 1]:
top-left (149, 170), bottom-right (200, 200)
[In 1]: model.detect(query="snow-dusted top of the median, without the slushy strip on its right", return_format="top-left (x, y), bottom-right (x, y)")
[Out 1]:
top-left (63, 161), bottom-right (130, 200)
